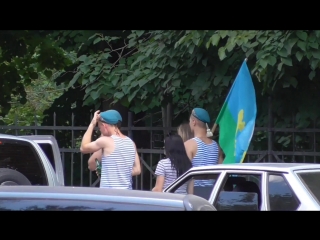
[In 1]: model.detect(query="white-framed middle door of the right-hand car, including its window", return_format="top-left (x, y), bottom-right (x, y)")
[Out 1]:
top-left (209, 170), bottom-right (266, 211)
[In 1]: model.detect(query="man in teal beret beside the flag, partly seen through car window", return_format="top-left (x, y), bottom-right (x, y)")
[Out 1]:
top-left (185, 108), bottom-right (223, 199)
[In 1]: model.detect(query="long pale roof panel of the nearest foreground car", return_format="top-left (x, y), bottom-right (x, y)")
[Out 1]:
top-left (0, 186), bottom-right (185, 208)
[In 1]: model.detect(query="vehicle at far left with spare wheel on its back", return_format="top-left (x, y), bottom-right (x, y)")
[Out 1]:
top-left (0, 134), bottom-right (64, 186)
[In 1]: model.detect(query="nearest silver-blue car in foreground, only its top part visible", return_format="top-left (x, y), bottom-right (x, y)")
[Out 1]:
top-left (0, 186), bottom-right (216, 211)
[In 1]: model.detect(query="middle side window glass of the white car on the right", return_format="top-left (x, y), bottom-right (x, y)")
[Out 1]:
top-left (213, 173), bottom-right (262, 211)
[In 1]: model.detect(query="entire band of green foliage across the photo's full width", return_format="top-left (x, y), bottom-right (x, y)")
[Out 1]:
top-left (0, 30), bottom-right (320, 152)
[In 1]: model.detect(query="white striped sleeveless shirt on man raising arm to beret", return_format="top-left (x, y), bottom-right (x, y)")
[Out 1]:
top-left (100, 135), bottom-right (136, 189)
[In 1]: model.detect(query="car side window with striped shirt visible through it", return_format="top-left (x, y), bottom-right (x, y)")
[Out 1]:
top-left (170, 172), bottom-right (220, 200)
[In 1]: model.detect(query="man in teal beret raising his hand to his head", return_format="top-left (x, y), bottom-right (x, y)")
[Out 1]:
top-left (80, 110), bottom-right (141, 189)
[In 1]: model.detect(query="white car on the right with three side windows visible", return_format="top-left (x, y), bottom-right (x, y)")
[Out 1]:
top-left (164, 163), bottom-right (320, 211)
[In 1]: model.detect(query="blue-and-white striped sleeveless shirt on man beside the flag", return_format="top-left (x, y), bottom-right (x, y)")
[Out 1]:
top-left (192, 137), bottom-right (219, 187)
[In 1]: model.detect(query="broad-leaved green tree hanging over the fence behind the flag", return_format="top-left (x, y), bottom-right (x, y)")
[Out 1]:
top-left (56, 30), bottom-right (320, 152)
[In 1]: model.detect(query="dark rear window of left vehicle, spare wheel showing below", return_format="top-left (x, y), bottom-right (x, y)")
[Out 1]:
top-left (0, 139), bottom-right (48, 186)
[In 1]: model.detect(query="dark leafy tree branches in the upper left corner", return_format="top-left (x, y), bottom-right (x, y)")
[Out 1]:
top-left (0, 30), bottom-right (72, 117)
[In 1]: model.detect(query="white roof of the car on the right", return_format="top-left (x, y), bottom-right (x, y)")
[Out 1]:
top-left (189, 163), bottom-right (320, 172)
